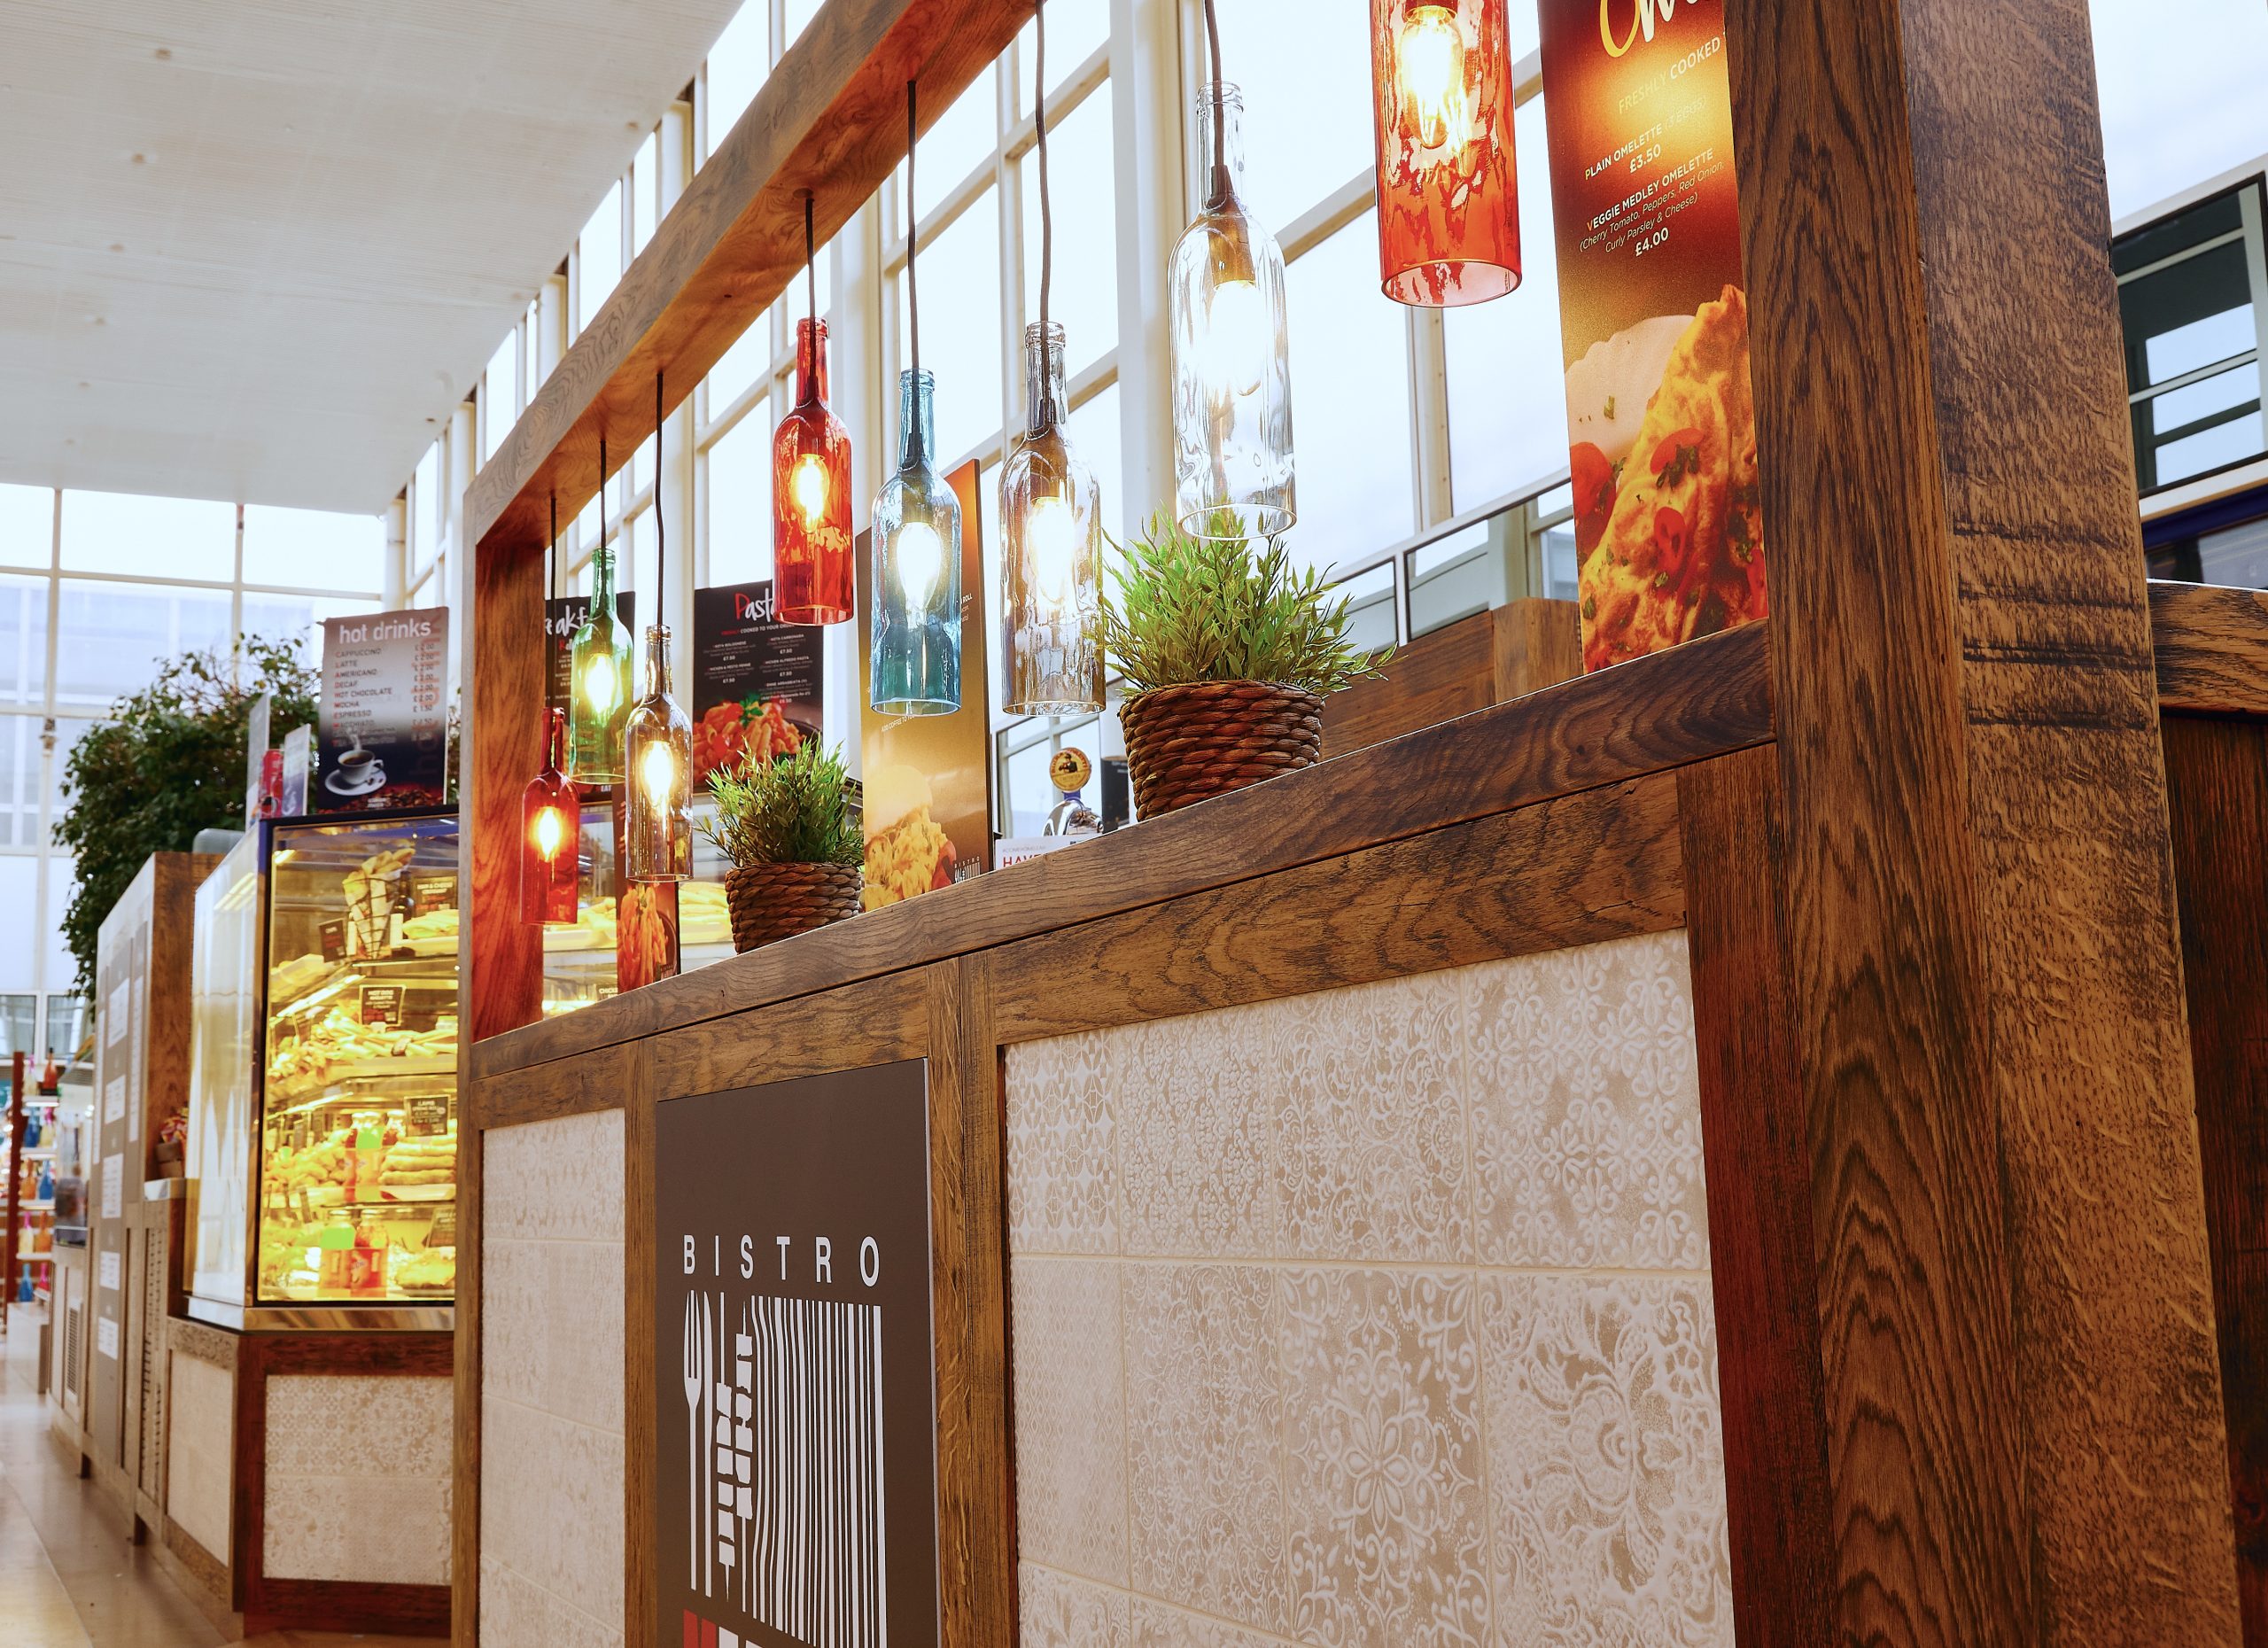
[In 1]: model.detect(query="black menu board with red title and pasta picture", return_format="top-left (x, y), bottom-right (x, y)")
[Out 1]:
top-left (692, 583), bottom-right (826, 787)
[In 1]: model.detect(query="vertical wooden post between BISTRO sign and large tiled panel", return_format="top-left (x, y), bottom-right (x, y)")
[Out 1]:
top-left (925, 954), bottom-right (1016, 1644)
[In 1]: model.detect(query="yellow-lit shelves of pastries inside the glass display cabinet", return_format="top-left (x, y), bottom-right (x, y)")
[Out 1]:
top-left (254, 813), bottom-right (458, 1306)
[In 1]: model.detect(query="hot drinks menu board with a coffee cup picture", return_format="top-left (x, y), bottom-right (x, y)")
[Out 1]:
top-left (308, 608), bottom-right (449, 813)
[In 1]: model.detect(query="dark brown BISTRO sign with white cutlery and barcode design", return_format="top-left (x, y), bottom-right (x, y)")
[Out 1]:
top-left (657, 1061), bottom-right (939, 1648)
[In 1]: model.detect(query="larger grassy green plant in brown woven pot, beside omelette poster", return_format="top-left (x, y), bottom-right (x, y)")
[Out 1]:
top-left (1102, 512), bottom-right (1388, 819)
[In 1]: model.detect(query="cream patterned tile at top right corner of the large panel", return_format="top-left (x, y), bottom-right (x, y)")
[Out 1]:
top-left (1456, 932), bottom-right (1708, 1270)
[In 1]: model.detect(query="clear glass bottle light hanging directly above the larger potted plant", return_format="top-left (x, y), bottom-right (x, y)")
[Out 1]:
top-left (1168, 84), bottom-right (1300, 537)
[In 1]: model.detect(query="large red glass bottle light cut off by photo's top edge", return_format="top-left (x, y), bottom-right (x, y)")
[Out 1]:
top-left (1370, 0), bottom-right (1519, 308)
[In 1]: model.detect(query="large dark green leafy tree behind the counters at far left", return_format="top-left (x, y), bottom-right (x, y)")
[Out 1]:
top-left (54, 634), bottom-right (320, 999)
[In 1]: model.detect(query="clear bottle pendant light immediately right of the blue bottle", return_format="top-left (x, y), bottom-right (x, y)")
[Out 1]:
top-left (1000, 322), bottom-right (1102, 716)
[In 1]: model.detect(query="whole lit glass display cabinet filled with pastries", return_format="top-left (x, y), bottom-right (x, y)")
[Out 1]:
top-left (190, 812), bottom-right (461, 1328)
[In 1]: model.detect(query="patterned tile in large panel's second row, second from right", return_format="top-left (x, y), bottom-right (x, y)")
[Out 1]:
top-left (1281, 1270), bottom-right (1490, 1648)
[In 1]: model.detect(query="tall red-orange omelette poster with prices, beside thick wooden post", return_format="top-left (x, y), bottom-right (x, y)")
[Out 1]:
top-left (1540, 0), bottom-right (1765, 669)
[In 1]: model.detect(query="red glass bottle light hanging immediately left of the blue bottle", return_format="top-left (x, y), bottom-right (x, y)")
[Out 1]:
top-left (771, 320), bottom-right (855, 624)
